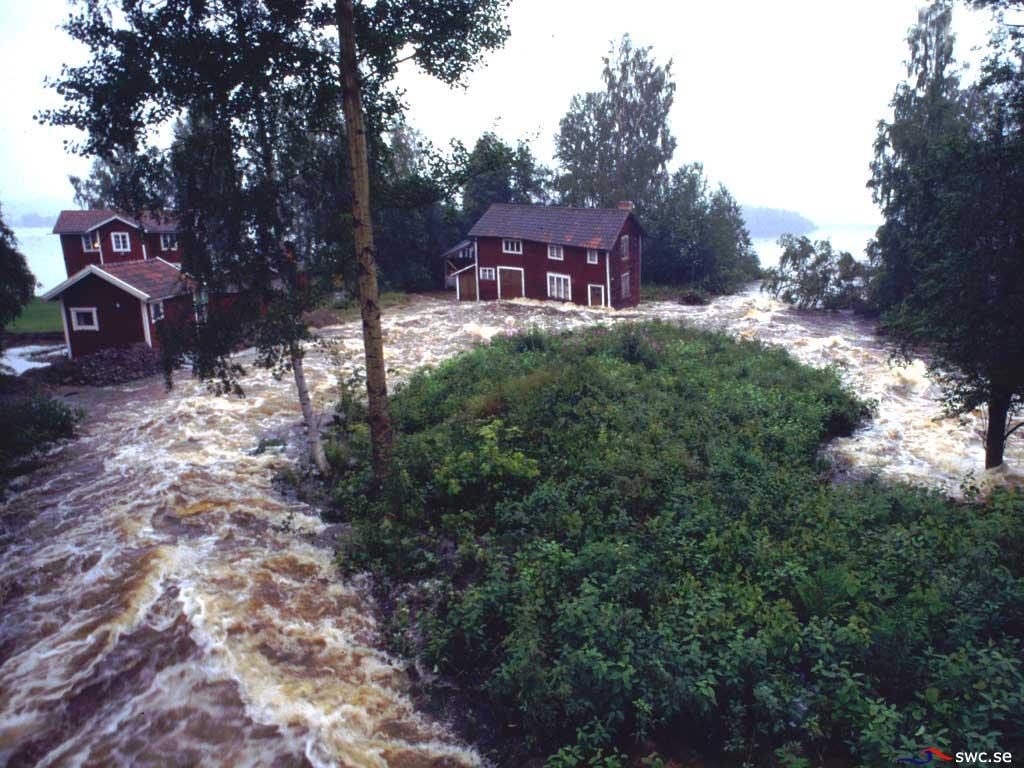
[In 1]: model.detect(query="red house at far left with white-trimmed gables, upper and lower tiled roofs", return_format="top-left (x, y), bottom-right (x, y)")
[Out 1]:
top-left (43, 210), bottom-right (200, 358)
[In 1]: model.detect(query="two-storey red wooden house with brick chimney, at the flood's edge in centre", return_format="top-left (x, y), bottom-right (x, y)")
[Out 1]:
top-left (453, 203), bottom-right (644, 309)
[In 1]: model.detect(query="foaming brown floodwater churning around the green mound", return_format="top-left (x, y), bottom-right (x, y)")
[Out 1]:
top-left (0, 288), bottom-right (1024, 766)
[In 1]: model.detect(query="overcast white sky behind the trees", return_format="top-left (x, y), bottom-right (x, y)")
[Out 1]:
top-left (0, 0), bottom-right (987, 226)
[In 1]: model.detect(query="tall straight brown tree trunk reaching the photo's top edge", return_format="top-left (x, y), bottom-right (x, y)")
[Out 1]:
top-left (335, 0), bottom-right (391, 485)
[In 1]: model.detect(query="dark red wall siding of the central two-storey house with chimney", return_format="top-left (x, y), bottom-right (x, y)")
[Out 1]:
top-left (476, 218), bottom-right (641, 308)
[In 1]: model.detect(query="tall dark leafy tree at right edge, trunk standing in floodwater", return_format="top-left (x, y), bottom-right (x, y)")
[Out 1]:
top-left (870, 0), bottom-right (1024, 467)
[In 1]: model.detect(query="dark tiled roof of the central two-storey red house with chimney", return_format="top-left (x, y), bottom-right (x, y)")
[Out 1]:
top-left (469, 203), bottom-right (633, 251)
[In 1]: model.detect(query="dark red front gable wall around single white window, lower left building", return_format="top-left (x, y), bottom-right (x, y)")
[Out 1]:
top-left (61, 274), bottom-right (145, 357)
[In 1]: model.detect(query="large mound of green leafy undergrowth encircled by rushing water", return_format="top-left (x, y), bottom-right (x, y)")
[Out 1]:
top-left (330, 324), bottom-right (1024, 766)
